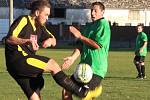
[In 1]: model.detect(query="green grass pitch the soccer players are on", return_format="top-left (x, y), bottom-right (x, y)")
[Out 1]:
top-left (0, 47), bottom-right (150, 100)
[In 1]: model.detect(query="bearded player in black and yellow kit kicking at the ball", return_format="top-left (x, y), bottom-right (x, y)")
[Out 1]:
top-left (5, 0), bottom-right (87, 100)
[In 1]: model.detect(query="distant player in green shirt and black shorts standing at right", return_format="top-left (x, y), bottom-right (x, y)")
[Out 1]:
top-left (134, 24), bottom-right (148, 79)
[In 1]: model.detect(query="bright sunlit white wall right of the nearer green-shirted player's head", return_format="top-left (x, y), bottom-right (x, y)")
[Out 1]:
top-left (104, 9), bottom-right (150, 26)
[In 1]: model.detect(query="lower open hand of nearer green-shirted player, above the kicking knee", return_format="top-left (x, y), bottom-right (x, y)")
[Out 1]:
top-left (61, 57), bottom-right (74, 70)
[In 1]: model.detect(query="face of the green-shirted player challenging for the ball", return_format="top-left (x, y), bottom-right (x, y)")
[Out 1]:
top-left (91, 5), bottom-right (104, 21)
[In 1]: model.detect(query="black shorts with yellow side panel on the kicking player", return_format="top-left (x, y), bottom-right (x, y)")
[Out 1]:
top-left (6, 55), bottom-right (49, 99)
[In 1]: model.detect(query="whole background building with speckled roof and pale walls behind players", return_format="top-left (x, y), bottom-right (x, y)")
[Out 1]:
top-left (0, 0), bottom-right (150, 43)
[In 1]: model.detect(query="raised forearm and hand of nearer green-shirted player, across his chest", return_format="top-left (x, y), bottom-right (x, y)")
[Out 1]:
top-left (69, 26), bottom-right (100, 49)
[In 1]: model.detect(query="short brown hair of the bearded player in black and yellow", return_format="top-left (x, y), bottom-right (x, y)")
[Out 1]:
top-left (30, 0), bottom-right (51, 14)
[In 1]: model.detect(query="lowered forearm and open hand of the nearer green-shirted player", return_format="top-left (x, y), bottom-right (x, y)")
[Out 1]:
top-left (62, 49), bottom-right (80, 69)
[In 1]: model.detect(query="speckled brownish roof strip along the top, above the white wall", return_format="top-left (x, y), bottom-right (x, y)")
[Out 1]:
top-left (50, 0), bottom-right (150, 9)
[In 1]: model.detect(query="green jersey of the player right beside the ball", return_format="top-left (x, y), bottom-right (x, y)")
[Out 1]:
top-left (80, 18), bottom-right (110, 78)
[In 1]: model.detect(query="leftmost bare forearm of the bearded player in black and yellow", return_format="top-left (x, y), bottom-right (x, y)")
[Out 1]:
top-left (6, 36), bottom-right (31, 45)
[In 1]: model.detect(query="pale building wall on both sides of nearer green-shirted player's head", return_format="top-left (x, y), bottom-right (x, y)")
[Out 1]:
top-left (49, 9), bottom-right (150, 26)
